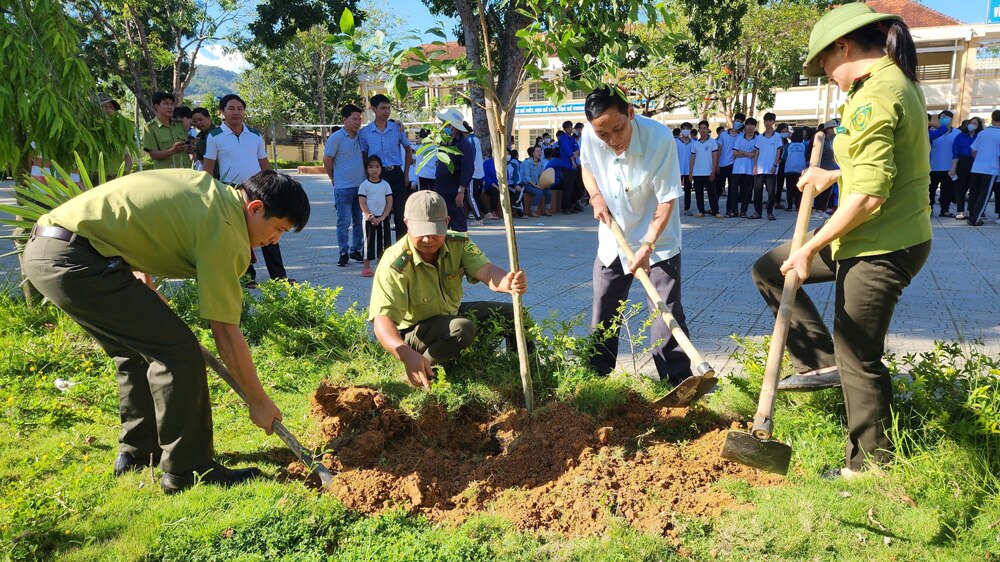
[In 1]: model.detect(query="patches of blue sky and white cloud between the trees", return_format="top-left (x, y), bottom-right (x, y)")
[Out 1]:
top-left (199, 0), bottom-right (990, 71)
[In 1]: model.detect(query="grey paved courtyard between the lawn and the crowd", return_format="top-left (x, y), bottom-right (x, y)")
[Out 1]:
top-left (0, 176), bottom-right (1000, 374)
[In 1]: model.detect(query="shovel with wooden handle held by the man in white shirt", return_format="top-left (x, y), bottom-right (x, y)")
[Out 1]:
top-left (610, 217), bottom-right (718, 408)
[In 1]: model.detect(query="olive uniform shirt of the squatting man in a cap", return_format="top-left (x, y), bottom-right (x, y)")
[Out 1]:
top-left (368, 233), bottom-right (490, 330)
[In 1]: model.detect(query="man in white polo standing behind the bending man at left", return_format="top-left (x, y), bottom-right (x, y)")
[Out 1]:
top-left (202, 94), bottom-right (295, 288)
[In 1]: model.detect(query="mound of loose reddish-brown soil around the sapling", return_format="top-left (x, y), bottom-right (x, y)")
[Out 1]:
top-left (289, 384), bottom-right (782, 536)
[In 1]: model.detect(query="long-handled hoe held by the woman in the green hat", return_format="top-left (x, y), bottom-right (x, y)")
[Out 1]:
top-left (722, 132), bottom-right (825, 474)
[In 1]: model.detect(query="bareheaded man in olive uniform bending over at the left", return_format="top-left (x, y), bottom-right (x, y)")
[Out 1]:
top-left (24, 170), bottom-right (309, 493)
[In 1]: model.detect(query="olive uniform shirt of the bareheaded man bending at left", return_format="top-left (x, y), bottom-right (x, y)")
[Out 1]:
top-left (38, 170), bottom-right (250, 324)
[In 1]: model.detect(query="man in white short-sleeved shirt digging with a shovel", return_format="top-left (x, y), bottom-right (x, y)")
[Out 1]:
top-left (580, 87), bottom-right (691, 384)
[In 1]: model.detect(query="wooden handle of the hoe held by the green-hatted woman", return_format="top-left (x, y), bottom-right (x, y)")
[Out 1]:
top-left (752, 132), bottom-right (826, 440)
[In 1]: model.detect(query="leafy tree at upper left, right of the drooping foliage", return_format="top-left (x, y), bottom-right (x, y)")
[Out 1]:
top-left (67, 0), bottom-right (249, 119)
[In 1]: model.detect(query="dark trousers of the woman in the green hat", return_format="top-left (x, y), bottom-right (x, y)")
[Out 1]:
top-left (753, 229), bottom-right (931, 470)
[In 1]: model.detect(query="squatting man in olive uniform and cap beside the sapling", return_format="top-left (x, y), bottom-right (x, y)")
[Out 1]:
top-left (368, 191), bottom-right (528, 387)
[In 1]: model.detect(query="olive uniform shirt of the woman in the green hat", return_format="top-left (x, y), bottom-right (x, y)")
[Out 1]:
top-left (831, 57), bottom-right (931, 260)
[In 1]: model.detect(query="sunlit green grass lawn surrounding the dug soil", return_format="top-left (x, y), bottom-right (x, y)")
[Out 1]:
top-left (0, 282), bottom-right (1000, 561)
